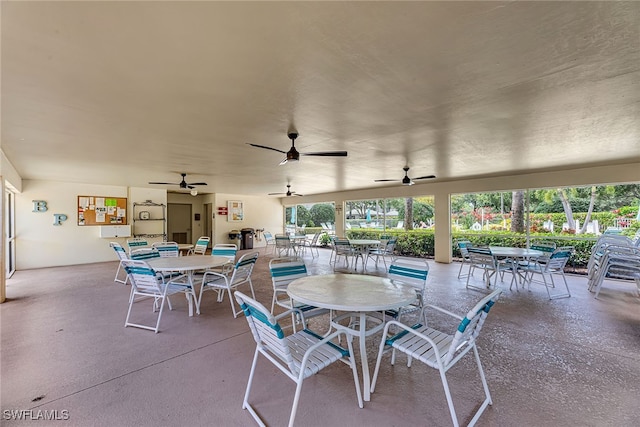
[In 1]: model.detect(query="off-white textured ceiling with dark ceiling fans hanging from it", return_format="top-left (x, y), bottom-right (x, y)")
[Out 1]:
top-left (1, 2), bottom-right (640, 195)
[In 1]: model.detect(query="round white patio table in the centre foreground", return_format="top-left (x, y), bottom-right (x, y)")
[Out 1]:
top-left (287, 274), bottom-right (416, 401)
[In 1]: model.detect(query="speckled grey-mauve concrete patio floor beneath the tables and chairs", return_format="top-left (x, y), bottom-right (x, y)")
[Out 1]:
top-left (0, 249), bottom-right (640, 426)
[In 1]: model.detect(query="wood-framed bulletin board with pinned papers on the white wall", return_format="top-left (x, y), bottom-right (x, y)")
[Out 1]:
top-left (78, 196), bottom-right (128, 226)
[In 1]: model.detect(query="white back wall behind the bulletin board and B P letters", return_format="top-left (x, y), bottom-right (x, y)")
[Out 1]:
top-left (16, 180), bottom-right (282, 270)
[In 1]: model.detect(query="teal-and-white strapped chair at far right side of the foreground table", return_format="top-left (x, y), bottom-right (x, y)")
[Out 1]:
top-left (385, 257), bottom-right (429, 321)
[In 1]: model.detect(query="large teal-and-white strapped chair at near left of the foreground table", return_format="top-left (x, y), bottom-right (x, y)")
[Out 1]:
top-left (235, 291), bottom-right (363, 427)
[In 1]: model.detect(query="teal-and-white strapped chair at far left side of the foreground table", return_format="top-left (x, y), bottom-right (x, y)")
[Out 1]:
top-left (269, 257), bottom-right (329, 332)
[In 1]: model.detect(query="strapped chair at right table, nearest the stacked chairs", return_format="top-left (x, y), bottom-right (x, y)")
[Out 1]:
top-left (518, 246), bottom-right (574, 299)
